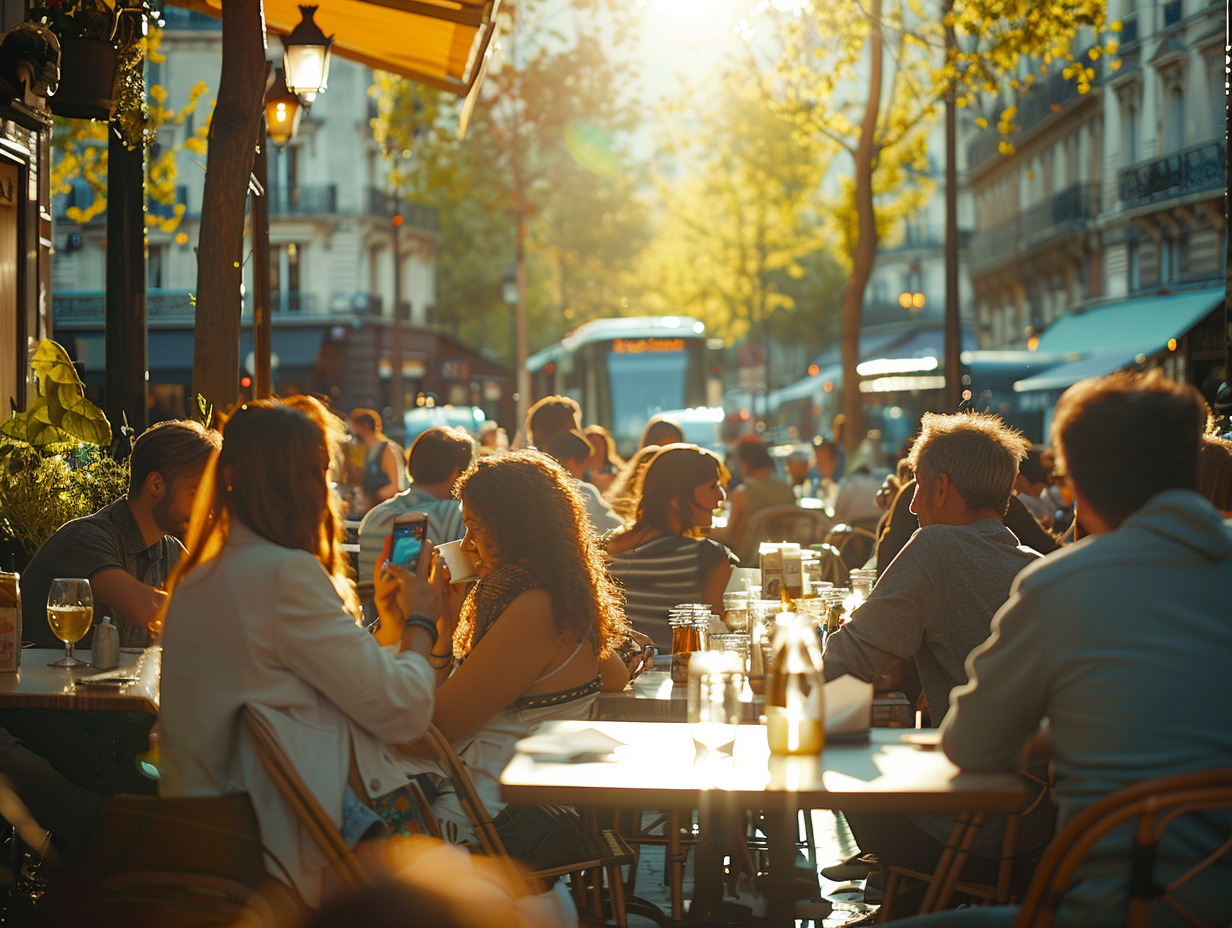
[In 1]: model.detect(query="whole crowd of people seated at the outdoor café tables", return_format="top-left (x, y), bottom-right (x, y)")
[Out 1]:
top-left (0, 373), bottom-right (1232, 926)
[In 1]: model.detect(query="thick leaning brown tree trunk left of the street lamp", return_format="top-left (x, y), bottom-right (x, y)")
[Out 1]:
top-left (192, 0), bottom-right (265, 419)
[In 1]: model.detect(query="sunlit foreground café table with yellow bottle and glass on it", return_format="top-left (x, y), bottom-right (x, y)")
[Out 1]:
top-left (500, 721), bottom-right (1025, 926)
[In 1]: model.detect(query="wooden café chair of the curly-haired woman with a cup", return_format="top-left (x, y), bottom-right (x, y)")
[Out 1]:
top-left (424, 725), bottom-right (634, 928)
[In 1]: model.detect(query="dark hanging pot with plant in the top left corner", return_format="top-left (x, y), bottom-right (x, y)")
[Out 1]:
top-left (30, 0), bottom-right (116, 120)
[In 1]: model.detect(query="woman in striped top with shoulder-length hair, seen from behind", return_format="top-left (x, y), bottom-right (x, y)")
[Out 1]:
top-left (604, 444), bottom-right (736, 653)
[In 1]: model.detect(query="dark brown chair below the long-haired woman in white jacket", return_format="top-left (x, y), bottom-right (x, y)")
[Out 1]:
top-left (39, 794), bottom-right (298, 928)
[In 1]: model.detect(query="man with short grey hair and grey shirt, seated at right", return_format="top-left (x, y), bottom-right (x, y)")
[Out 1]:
top-left (823, 413), bottom-right (1047, 897)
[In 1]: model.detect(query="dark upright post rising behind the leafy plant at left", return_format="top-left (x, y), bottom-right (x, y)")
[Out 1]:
top-left (103, 111), bottom-right (149, 433)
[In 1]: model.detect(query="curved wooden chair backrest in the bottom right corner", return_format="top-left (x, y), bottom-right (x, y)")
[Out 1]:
top-left (1014, 768), bottom-right (1232, 928)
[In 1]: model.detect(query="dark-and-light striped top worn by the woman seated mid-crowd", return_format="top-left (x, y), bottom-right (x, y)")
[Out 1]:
top-left (607, 535), bottom-right (736, 654)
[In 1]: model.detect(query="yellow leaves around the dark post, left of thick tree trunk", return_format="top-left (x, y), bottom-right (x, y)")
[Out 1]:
top-left (51, 28), bottom-right (209, 232)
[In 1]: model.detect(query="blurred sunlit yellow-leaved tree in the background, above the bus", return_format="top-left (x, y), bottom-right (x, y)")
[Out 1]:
top-left (638, 66), bottom-right (830, 352)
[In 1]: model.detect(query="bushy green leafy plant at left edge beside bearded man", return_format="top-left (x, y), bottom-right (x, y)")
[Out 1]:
top-left (0, 339), bottom-right (128, 553)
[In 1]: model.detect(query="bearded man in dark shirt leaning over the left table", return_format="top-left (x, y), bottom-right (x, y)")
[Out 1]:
top-left (21, 419), bottom-right (221, 648)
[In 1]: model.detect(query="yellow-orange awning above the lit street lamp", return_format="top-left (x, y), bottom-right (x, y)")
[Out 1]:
top-left (170, 0), bottom-right (500, 96)
